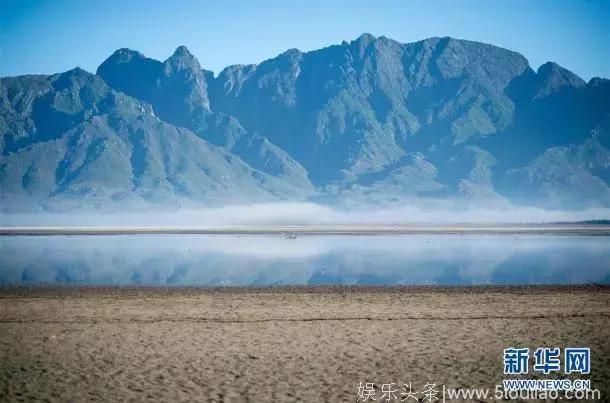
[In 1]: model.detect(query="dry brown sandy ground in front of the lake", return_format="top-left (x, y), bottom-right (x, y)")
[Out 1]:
top-left (0, 286), bottom-right (610, 401)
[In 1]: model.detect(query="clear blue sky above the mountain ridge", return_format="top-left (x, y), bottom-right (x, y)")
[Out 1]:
top-left (0, 0), bottom-right (610, 80)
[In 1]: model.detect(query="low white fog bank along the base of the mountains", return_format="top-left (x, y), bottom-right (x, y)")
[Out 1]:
top-left (0, 201), bottom-right (610, 227)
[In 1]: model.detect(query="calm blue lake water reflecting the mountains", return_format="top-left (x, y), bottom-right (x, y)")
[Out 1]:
top-left (0, 235), bottom-right (610, 286)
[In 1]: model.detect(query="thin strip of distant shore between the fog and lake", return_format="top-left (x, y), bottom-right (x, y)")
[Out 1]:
top-left (0, 223), bottom-right (610, 236)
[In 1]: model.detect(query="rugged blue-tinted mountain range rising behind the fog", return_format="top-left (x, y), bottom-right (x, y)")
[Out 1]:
top-left (0, 34), bottom-right (610, 211)
